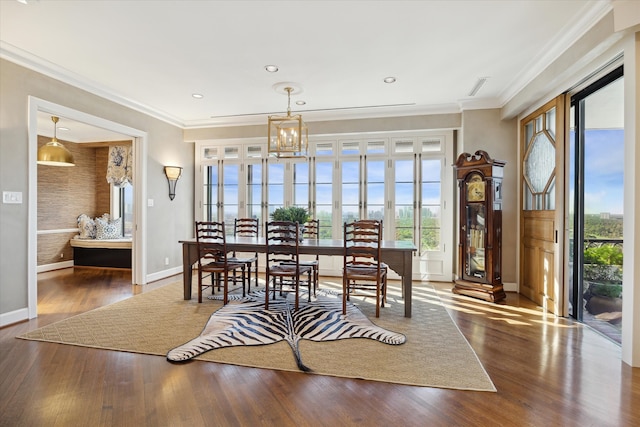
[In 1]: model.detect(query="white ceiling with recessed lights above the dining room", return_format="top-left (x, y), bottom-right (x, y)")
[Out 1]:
top-left (0, 0), bottom-right (611, 139)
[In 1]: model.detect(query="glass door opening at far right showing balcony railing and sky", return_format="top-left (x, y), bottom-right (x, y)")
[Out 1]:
top-left (568, 66), bottom-right (624, 344)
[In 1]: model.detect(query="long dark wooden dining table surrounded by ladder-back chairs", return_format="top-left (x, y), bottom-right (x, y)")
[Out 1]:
top-left (179, 236), bottom-right (416, 317)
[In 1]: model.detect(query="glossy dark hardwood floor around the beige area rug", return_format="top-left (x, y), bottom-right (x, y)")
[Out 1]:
top-left (0, 269), bottom-right (640, 426)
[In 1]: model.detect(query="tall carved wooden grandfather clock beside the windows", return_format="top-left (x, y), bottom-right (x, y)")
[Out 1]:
top-left (453, 150), bottom-right (506, 302)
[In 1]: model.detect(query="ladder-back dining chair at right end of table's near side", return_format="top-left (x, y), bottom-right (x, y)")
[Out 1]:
top-left (342, 220), bottom-right (388, 317)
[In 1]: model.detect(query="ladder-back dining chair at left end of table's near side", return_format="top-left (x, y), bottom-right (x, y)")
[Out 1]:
top-left (196, 221), bottom-right (245, 304)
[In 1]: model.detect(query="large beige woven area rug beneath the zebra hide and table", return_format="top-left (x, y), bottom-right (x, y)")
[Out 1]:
top-left (18, 282), bottom-right (496, 391)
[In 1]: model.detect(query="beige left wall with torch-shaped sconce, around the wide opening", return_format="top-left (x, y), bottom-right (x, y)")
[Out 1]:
top-left (0, 58), bottom-right (194, 316)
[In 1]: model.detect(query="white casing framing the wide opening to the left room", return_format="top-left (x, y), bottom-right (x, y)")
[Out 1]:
top-left (27, 96), bottom-right (147, 319)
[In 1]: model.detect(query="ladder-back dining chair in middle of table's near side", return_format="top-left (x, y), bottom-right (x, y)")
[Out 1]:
top-left (265, 221), bottom-right (313, 310)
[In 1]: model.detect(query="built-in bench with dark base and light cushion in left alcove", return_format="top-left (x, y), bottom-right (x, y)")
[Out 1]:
top-left (69, 238), bottom-right (131, 268)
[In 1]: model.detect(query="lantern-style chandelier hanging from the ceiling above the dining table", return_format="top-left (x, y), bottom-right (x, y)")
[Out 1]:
top-left (268, 84), bottom-right (309, 158)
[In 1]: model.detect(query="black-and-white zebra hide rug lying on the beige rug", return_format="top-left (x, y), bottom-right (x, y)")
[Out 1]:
top-left (167, 290), bottom-right (406, 372)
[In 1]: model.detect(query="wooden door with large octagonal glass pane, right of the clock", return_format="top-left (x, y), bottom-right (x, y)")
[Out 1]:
top-left (520, 96), bottom-right (566, 315)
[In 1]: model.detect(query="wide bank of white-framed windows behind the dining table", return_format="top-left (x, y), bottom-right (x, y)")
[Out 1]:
top-left (196, 131), bottom-right (454, 280)
